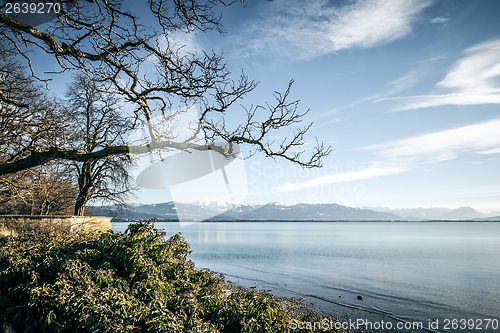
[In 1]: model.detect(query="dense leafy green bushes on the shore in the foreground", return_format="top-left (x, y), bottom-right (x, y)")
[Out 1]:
top-left (0, 221), bottom-right (340, 332)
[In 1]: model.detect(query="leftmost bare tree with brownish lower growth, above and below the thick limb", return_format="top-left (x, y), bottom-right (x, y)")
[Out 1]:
top-left (0, 43), bottom-right (76, 215)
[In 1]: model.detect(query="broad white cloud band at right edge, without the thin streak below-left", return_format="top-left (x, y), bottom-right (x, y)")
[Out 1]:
top-left (366, 119), bottom-right (500, 162)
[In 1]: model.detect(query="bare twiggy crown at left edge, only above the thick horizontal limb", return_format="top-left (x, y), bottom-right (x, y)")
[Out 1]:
top-left (0, 42), bottom-right (65, 179)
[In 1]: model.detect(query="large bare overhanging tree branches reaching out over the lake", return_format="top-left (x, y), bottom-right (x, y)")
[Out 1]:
top-left (0, 0), bottom-right (330, 175)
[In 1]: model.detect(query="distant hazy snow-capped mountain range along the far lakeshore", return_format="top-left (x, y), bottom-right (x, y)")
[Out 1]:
top-left (89, 202), bottom-right (500, 221)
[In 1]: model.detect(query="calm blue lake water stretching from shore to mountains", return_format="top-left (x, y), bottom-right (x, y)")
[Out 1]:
top-left (113, 222), bottom-right (500, 332)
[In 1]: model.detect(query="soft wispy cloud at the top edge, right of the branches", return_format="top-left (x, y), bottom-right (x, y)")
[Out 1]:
top-left (236, 0), bottom-right (432, 59)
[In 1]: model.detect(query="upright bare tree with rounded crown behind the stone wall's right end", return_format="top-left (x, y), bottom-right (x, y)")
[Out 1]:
top-left (67, 74), bottom-right (137, 215)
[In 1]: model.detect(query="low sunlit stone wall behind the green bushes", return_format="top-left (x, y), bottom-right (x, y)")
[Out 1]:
top-left (0, 215), bottom-right (111, 236)
